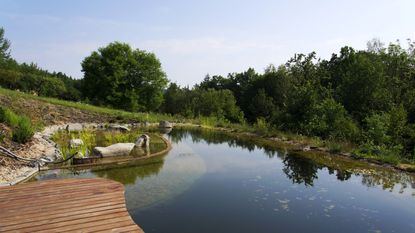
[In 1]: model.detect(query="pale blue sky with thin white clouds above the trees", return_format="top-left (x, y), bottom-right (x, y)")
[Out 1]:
top-left (0, 0), bottom-right (415, 86)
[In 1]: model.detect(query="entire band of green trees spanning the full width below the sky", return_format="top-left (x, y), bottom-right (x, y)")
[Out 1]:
top-left (0, 26), bottom-right (415, 161)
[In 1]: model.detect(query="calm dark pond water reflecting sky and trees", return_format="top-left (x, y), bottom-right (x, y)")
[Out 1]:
top-left (32, 129), bottom-right (415, 233)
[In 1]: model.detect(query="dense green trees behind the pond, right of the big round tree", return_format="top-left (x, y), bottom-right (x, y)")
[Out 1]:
top-left (162, 40), bottom-right (415, 160)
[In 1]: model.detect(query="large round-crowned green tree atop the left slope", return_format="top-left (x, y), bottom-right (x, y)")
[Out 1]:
top-left (82, 42), bottom-right (168, 111)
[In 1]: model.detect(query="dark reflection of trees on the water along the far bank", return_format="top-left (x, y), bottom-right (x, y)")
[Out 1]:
top-left (170, 128), bottom-right (415, 195)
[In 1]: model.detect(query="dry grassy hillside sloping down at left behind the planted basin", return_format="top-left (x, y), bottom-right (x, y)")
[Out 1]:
top-left (0, 88), bottom-right (174, 181)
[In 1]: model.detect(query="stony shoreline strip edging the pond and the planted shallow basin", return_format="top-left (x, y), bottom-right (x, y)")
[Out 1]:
top-left (0, 123), bottom-right (415, 186)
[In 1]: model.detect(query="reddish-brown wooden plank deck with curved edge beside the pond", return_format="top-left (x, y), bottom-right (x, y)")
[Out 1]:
top-left (0, 179), bottom-right (143, 232)
